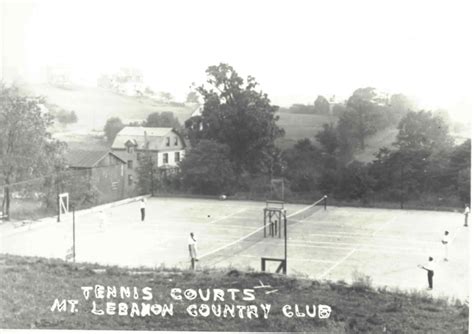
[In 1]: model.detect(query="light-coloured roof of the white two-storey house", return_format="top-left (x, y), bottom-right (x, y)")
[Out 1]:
top-left (112, 126), bottom-right (186, 150)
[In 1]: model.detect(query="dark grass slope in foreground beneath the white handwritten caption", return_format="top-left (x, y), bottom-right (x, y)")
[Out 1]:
top-left (0, 255), bottom-right (468, 333)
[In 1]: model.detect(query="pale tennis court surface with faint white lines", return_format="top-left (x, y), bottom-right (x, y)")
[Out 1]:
top-left (0, 198), bottom-right (470, 300)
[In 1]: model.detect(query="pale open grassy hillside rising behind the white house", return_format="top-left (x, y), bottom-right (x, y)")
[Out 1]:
top-left (21, 84), bottom-right (193, 130)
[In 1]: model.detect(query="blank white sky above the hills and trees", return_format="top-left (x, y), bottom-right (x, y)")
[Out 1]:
top-left (0, 0), bottom-right (474, 118)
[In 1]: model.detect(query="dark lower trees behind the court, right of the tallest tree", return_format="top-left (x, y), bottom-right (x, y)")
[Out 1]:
top-left (284, 111), bottom-right (471, 207)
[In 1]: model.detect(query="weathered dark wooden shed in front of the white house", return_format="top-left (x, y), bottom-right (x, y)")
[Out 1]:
top-left (66, 150), bottom-right (128, 203)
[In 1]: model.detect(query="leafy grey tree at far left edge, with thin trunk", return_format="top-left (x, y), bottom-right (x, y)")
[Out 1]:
top-left (0, 85), bottom-right (65, 216)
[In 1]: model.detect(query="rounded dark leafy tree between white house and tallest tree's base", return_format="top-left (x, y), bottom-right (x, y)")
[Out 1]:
top-left (180, 139), bottom-right (235, 195)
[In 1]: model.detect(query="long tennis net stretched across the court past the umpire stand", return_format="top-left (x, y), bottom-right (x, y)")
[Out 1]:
top-left (194, 196), bottom-right (327, 267)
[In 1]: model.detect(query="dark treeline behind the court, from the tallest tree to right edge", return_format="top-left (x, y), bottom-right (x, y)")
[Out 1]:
top-left (141, 64), bottom-right (471, 207)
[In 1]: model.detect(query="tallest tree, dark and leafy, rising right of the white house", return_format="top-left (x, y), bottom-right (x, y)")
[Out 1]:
top-left (186, 64), bottom-right (284, 176)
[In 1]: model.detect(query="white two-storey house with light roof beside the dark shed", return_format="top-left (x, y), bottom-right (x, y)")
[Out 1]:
top-left (112, 126), bottom-right (186, 191)
